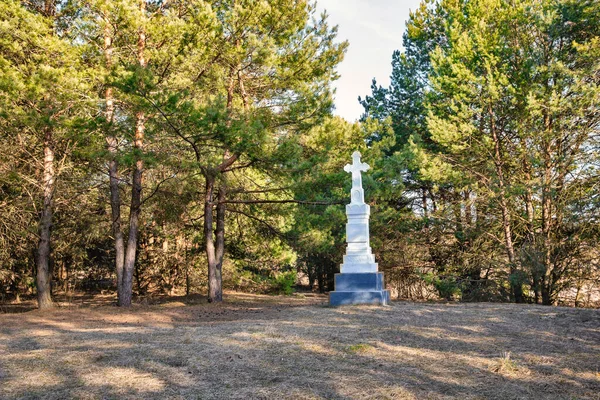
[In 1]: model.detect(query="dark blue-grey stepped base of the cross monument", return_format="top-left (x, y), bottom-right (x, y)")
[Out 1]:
top-left (329, 272), bottom-right (390, 306)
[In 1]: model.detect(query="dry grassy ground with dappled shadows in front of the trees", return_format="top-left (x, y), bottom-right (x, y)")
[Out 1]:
top-left (0, 293), bottom-right (600, 399)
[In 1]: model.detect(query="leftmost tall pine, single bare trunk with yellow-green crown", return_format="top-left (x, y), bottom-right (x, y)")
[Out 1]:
top-left (0, 0), bottom-right (86, 309)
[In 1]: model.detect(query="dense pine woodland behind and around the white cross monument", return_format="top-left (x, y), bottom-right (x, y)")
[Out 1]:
top-left (0, 0), bottom-right (600, 308)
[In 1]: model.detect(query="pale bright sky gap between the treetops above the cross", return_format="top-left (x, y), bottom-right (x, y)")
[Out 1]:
top-left (317, 0), bottom-right (421, 121)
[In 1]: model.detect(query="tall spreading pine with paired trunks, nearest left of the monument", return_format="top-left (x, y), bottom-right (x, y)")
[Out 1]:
top-left (149, 1), bottom-right (346, 302)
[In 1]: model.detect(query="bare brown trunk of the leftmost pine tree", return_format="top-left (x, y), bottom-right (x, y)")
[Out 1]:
top-left (36, 127), bottom-right (56, 310)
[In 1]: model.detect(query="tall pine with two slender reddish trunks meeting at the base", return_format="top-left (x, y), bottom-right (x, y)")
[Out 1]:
top-left (77, 0), bottom-right (207, 306)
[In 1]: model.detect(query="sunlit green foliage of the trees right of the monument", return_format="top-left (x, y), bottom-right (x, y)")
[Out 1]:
top-left (361, 0), bottom-right (600, 304)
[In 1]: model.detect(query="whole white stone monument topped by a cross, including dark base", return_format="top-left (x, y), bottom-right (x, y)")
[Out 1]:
top-left (329, 151), bottom-right (390, 306)
